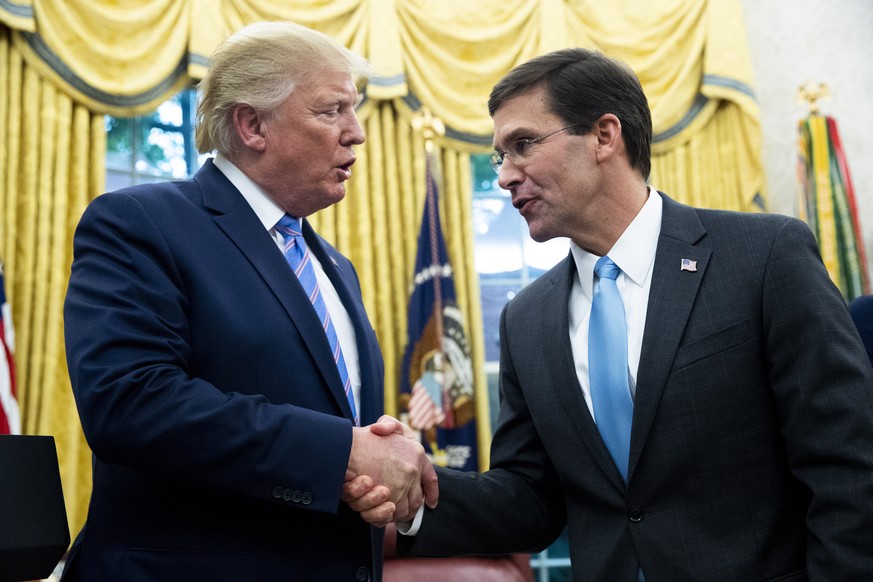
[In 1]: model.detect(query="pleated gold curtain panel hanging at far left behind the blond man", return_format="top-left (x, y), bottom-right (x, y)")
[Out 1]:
top-left (0, 27), bottom-right (106, 540)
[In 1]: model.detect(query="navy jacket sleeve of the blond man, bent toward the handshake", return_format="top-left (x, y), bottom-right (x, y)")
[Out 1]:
top-left (64, 193), bottom-right (351, 513)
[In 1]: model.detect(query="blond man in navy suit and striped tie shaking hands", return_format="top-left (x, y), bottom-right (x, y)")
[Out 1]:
top-left (63, 23), bottom-right (437, 582)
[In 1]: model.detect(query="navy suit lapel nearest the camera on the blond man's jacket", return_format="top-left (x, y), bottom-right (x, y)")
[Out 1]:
top-left (194, 160), bottom-right (352, 418)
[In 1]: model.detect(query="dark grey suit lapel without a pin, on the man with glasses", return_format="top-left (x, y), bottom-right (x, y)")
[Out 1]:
top-left (540, 255), bottom-right (624, 491)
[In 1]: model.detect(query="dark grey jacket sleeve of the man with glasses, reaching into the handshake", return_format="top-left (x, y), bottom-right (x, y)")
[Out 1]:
top-left (398, 309), bottom-right (566, 556)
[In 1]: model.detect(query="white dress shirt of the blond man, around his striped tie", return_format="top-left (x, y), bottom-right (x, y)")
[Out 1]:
top-left (214, 154), bottom-right (361, 414)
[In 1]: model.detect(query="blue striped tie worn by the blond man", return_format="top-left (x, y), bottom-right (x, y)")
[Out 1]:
top-left (276, 214), bottom-right (361, 426)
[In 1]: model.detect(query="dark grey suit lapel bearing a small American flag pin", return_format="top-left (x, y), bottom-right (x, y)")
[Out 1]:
top-left (628, 193), bottom-right (712, 479)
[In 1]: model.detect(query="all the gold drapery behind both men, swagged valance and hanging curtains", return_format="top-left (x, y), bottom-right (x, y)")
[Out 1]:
top-left (0, 0), bottom-right (764, 531)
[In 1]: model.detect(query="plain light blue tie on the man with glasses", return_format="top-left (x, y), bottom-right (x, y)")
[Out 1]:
top-left (588, 256), bottom-right (634, 483)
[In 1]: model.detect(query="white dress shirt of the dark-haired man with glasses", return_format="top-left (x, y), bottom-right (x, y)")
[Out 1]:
top-left (569, 186), bottom-right (663, 422)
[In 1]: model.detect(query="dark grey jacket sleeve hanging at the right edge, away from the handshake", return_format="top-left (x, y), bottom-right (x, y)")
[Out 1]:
top-left (763, 220), bottom-right (873, 580)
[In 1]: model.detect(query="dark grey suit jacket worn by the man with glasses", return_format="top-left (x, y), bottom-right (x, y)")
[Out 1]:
top-left (401, 197), bottom-right (873, 582)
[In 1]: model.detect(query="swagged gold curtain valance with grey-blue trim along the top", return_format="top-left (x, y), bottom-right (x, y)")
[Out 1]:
top-left (0, 0), bottom-right (758, 153)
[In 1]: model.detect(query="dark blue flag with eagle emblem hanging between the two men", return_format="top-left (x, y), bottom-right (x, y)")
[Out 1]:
top-left (398, 165), bottom-right (479, 471)
